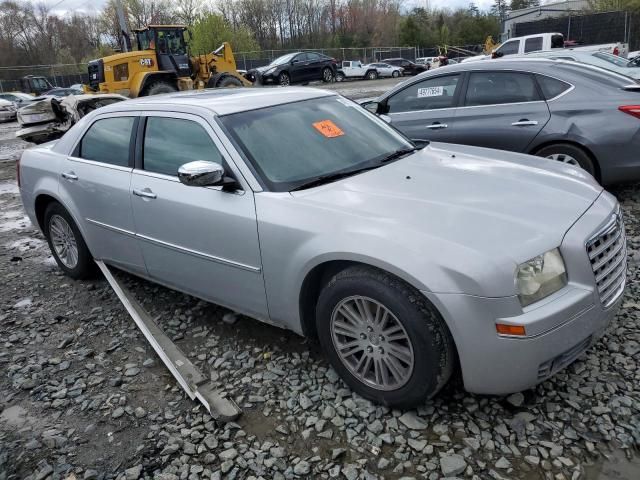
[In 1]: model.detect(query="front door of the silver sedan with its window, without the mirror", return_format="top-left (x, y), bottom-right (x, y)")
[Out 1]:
top-left (131, 113), bottom-right (268, 318)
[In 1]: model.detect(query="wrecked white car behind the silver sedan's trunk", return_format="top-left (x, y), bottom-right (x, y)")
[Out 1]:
top-left (16, 94), bottom-right (127, 144)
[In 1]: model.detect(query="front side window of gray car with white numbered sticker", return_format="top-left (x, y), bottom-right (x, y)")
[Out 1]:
top-left (387, 75), bottom-right (460, 113)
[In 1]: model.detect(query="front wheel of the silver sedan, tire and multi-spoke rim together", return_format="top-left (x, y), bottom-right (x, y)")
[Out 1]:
top-left (316, 266), bottom-right (455, 408)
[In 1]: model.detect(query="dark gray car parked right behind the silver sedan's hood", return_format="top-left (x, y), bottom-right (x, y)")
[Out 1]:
top-left (363, 59), bottom-right (640, 184)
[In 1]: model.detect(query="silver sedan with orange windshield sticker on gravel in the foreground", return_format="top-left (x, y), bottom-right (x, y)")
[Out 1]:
top-left (18, 88), bottom-right (626, 407)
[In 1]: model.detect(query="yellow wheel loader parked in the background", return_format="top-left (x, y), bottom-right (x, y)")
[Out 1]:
top-left (84, 25), bottom-right (251, 98)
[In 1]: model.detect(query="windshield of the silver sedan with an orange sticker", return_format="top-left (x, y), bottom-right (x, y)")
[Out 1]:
top-left (220, 96), bottom-right (414, 192)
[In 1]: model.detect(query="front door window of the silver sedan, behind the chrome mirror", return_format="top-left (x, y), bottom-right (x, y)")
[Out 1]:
top-left (143, 117), bottom-right (223, 176)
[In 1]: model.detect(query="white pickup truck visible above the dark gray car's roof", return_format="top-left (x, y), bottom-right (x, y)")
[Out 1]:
top-left (463, 33), bottom-right (629, 62)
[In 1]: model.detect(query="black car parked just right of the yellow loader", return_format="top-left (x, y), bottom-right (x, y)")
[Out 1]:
top-left (245, 52), bottom-right (338, 85)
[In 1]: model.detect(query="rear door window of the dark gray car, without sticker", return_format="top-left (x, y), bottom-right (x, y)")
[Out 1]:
top-left (465, 72), bottom-right (542, 106)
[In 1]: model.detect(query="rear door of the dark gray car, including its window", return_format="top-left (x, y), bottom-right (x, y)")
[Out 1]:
top-left (456, 71), bottom-right (551, 152)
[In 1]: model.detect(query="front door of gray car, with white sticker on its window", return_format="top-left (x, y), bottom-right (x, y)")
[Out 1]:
top-left (383, 74), bottom-right (462, 143)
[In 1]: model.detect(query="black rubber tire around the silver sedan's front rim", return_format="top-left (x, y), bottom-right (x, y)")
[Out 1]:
top-left (316, 266), bottom-right (456, 408)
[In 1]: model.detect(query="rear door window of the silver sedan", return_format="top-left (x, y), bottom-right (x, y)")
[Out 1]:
top-left (79, 117), bottom-right (135, 167)
